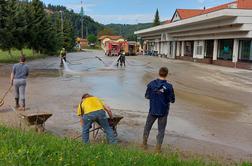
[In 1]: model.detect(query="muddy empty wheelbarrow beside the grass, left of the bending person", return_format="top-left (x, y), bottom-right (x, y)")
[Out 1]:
top-left (18, 112), bottom-right (52, 133)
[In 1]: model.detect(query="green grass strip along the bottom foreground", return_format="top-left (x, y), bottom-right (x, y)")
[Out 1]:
top-left (0, 126), bottom-right (251, 166)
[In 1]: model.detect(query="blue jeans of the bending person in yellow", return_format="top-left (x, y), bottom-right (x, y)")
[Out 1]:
top-left (82, 110), bottom-right (117, 144)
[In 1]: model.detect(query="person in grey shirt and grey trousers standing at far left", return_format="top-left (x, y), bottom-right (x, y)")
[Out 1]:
top-left (10, 55), bottom-right (29, 111)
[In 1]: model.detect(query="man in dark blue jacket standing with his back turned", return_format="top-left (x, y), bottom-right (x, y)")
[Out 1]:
top-left (143, 67), bottom-right (175, 153)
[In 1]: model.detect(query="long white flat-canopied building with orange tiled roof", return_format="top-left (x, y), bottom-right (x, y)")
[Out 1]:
top-left (135, 0), bottom-right (252, 69)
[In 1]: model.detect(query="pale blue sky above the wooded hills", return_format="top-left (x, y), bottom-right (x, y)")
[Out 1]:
top-left (42, 0), bottom-right (234, 24)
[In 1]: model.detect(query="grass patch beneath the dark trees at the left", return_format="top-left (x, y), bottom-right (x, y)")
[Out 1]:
top-left (0, 49), bottom-right (46, 63)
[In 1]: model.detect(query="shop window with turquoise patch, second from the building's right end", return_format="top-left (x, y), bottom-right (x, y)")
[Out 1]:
top-left (218, 39), bottom-right (234, 61)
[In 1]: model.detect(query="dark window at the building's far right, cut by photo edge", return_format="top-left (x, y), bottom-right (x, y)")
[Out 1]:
top-left (239, 40), bottom-right (252, 62)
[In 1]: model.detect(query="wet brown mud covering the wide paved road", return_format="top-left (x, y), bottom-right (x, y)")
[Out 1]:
top-left (0, 51), bottom-right (252, 160)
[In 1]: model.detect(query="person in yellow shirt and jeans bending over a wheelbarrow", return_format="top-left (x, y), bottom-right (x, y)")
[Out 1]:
top-left (77, 93), bottom-right (117, 144)
